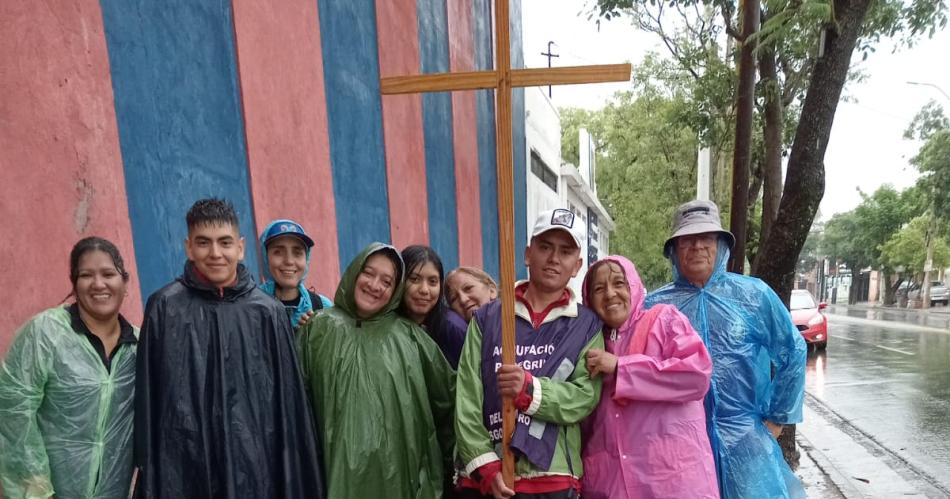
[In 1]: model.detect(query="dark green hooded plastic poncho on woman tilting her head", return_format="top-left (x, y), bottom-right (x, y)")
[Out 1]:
top-left (298, 243), bottom-right (455, 499)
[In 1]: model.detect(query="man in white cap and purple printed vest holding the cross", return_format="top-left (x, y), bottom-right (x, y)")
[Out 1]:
top-left (455, 209), bottom-right (604, 499)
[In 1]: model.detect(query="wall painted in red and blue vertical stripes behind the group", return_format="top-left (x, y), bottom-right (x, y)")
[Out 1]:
top-left (0, 0), bottom-right (526, 360)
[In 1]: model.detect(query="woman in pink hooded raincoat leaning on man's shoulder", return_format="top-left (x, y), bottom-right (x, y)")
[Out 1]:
top-left (583, 256), bottom-right (719, 499)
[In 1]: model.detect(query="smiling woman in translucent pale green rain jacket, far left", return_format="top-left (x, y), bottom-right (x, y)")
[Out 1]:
top-left (0, 237), bottom-right (138, 499)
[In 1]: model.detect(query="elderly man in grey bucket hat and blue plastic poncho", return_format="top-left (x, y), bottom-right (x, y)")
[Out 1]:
top-left (647, 201), bottom-right (806, 499)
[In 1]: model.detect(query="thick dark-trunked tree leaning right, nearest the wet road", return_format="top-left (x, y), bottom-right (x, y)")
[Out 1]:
top-left (596, 0), bottom-right (947, 463)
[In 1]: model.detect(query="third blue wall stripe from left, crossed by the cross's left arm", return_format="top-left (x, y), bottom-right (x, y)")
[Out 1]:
top-left (417, 0), bottom-right (458, 269)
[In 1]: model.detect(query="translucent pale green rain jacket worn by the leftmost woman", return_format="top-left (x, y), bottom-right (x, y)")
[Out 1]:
top-left (0, 307), bottom-right (138, 499)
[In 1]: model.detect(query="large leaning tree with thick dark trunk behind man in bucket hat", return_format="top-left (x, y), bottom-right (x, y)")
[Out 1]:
top-left (594, 0), bottom-right (947, 301)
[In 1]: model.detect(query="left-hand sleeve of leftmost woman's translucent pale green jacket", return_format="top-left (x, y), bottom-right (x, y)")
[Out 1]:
top-left (0, 315), bottom-right (54, 499)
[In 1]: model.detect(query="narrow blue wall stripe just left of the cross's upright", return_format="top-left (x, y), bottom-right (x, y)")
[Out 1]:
top-left (472, 0), bottom-right (499, 280)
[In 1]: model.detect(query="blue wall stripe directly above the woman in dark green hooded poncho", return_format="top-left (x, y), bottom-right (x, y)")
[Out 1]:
top-left (313, 0), bottom-right (392, 268)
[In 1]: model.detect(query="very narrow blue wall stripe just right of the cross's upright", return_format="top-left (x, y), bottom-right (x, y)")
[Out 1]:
top-left (509, 0), bottom-right (532, 279)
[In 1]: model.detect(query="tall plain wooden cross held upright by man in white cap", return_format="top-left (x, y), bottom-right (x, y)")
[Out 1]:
top-left (380, 0), bottom-right (630, 489)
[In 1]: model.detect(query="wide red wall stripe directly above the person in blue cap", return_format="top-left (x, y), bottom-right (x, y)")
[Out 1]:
top-left (233, 0), bottom-right (340, 299)
